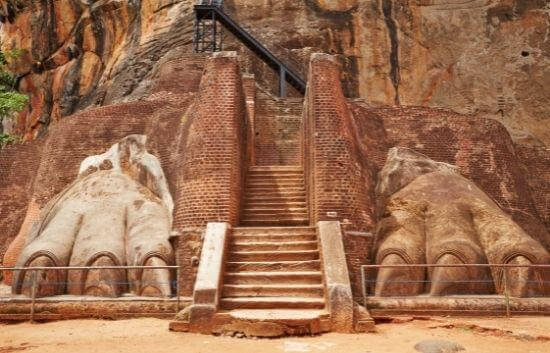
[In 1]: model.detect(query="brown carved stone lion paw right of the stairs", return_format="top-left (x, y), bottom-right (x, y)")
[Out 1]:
top-left (375, 148), bottom-right (550, 297)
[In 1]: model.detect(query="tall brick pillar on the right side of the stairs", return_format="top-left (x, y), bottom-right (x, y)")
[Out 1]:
top-left (304, 54), bottom-right (375, 296)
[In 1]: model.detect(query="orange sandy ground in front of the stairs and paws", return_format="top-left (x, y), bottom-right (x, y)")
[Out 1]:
top-left (0, 317), bottom-right (550, 353)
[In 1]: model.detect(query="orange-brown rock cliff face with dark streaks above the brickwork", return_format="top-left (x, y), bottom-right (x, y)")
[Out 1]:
top-left (0, 0), bottom-right (550, 146)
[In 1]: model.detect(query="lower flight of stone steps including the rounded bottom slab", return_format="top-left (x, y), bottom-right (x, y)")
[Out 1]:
top-left (210, 226), bottom-right (331, 337)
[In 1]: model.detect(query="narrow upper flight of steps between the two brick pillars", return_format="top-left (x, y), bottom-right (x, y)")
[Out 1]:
top-left (241, 166), bottom-right (309, 226)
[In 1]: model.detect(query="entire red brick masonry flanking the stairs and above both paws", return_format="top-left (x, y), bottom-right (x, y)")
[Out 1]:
top-left (0, 54), bottom-right (550, 306)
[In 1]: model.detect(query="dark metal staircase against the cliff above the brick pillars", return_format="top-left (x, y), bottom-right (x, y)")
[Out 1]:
top-left (194, 0), bottom-right (306, 97)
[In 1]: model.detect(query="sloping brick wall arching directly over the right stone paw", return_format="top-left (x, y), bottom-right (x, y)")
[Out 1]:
top-left (359, 107), bottom-right (550, 247)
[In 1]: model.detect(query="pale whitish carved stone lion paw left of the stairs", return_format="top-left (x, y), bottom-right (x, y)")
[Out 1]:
top-left (12, 135), bottom-right (174, 296)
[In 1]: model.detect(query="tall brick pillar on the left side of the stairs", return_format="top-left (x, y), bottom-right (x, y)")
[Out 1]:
top-left (174, 52), bottom-right (246, 296)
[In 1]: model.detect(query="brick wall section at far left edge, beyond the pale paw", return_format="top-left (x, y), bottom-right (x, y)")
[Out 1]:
top-left (0, 141), bottom-right (42, 263)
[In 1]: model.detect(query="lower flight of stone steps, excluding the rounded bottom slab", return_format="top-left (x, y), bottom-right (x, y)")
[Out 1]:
top-left (221, 227), bottom-right (325, 309)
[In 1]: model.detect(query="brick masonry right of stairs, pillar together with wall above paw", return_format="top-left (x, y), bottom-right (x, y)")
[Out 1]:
top-left (304, 55), bottom-right (550, 296)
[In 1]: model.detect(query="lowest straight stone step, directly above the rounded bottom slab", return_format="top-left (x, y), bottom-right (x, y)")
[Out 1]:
top-left (220, 297), bottom-right (325, 310)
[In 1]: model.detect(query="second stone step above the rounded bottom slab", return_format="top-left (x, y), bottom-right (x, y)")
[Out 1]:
top-left (222, 284), bottom-right (324, 298)
